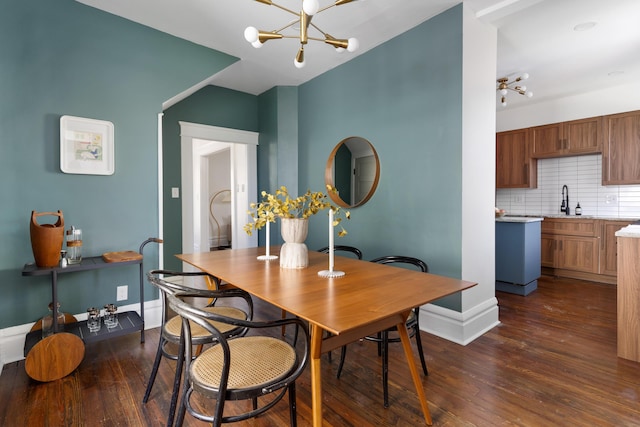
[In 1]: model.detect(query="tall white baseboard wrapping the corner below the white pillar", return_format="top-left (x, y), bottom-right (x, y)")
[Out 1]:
top-left (420, 297), bottom-right (500, 345)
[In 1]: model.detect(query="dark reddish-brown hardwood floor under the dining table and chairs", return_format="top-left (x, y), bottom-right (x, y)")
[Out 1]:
top-left (0, 278), bottom-right (640, 427)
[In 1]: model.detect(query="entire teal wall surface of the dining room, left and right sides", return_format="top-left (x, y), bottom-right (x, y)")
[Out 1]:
top-left (0, 0), bottom-right (470, 328)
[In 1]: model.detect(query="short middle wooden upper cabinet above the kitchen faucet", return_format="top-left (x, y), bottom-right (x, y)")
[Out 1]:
top-left (531, 117), bottom-right (602, 158)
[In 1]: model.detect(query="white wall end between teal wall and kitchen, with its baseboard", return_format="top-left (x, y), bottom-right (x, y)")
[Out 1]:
top-left (448, 5), bottom-right (499, 344)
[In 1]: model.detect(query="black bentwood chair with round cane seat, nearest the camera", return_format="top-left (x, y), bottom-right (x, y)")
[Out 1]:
top-left (168, 292), bottom-right (310, 427)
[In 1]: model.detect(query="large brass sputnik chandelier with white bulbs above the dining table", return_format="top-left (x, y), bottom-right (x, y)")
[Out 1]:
top-left (244, 0), bottom-right (360, 68)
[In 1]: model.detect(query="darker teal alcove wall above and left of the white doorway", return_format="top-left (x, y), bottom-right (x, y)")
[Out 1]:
top-left (162, 86), bottom-right (258, 270)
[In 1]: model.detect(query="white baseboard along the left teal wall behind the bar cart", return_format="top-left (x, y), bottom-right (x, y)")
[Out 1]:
top-left (0, 299), bottom-right (162, 373)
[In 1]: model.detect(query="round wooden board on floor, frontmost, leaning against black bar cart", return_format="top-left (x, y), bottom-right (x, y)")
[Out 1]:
top-left (24, 332), bottom-right (84, 382)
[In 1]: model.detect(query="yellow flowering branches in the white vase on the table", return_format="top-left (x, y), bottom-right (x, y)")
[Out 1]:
top-left (244, 185), bottom-right (351, 237)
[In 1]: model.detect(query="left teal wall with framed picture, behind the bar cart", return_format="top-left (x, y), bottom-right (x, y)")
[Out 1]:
top-left (0, 0), bottom-right (236, 328)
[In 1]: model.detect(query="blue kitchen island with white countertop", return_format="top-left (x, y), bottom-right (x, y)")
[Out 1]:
top-left (496, 216), bottom-right (543, 296)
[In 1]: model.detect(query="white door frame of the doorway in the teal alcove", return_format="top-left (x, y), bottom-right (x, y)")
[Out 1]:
top-left (179, 122), bottom-right (258, 253)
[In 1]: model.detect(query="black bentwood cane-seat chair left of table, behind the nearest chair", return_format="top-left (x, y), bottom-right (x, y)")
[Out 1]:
top-left (142, 270), bottom-right (253, 426)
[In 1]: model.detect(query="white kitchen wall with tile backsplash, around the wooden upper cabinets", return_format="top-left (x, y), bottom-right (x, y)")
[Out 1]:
top-left (496, 83), bottom-right (640, 218)
